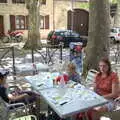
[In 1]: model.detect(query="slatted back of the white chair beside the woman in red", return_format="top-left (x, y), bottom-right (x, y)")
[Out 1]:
top-left (86, 69), bottom-right (98, 83)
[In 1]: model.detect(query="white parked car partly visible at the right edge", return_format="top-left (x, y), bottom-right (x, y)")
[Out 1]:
top-left (110, 27), bottom-right (120, 43)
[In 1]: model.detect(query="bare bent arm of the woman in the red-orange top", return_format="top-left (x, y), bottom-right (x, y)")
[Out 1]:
top-left (103, 83), bottom-right (119, 99)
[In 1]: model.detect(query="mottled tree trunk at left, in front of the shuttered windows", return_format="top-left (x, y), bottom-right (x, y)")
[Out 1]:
top-left (24, 0), bottom-right (41, 49)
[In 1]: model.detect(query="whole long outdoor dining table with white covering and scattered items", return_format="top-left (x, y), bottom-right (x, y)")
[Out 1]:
top-left (25, 72), bottom-right (108, 118)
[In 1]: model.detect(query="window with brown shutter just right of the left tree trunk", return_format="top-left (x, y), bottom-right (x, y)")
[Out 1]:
top-left (40, 15), bottom-right (49, 29)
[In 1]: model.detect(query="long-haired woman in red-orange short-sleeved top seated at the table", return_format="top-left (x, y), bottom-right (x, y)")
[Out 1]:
top-left (89, 58), bottom-right (119, 120)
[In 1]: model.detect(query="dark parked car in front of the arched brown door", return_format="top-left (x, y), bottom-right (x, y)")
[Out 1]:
top-left (47, 30), bottom-right (87, 47)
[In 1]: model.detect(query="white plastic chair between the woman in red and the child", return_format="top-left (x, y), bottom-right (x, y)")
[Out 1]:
top-left (85, 69), bottom-right (98, 88)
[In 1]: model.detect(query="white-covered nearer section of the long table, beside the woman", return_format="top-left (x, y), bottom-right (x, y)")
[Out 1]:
top-left (39, 85), bottom-right (107, 118)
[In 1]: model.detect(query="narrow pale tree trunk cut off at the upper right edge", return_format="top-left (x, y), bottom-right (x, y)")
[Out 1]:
top-left (114, 0), bottom-right (120, 27)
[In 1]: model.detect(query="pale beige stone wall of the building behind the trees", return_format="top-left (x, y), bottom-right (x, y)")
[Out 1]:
top-left (0, 0), bottom-right (86, 38)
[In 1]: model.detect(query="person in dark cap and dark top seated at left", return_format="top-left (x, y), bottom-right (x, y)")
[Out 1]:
top-left (0, 71), bottom-right (37, 104)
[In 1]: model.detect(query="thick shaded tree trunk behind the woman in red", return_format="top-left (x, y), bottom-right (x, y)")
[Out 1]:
top-left (83, 0), bottom-right (110, 75)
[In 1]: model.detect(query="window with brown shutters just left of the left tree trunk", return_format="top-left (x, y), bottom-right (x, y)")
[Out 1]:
top-left (10, 15), bottom-right (28, 30)
